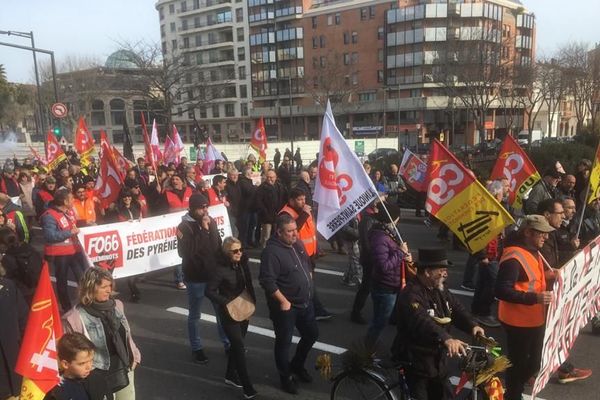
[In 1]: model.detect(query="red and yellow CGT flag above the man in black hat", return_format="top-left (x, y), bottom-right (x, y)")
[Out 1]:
top-left (425, 140), bottom-right (514, 253)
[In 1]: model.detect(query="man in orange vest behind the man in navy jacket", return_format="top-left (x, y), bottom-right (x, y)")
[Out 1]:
top-left (278, 188), bottom-right (333, 321)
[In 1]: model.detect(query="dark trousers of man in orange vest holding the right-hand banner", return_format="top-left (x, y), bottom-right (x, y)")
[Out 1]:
top-left (502, 324), bottom-right (545, 400)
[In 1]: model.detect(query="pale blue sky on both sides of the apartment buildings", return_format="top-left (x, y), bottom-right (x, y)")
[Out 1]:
top-left (0, 0), bottom-right (600, 82)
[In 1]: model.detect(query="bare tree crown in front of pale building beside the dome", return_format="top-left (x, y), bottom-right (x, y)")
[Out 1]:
top-left (119, 41), bottom-right (236, 130)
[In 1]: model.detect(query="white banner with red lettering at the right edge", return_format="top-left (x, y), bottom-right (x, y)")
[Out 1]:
top-left (533, 236), bottom-right (600, 398)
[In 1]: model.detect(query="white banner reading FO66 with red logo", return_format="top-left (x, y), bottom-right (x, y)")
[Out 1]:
top-left (78, 204), bottom-right (231, 278)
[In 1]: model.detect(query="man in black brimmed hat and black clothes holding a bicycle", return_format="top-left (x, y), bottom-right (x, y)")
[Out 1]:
top-left (392, 249), bottom-right (484, 400)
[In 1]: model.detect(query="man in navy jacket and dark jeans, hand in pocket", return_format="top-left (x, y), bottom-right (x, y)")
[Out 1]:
top-left (259, 214), bottom-right (319, 394)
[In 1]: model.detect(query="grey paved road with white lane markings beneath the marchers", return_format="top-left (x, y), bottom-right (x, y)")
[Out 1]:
top-left (44, 212), bottom-right (600, 400)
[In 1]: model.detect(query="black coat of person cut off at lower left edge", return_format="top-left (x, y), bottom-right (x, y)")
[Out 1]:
top-left (0, 278), bottom-right (27, 396)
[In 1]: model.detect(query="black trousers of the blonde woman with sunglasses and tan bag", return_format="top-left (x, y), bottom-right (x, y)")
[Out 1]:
top-left (221, 315), bottom-right (252, 389)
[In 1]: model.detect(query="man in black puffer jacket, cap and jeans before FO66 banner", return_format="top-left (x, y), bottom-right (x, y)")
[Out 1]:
top-left (177, 193), bottom-right (229, 364)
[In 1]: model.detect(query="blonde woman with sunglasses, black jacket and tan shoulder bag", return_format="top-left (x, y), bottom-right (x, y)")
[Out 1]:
top-left (206, 237), bottom-right (257, 399)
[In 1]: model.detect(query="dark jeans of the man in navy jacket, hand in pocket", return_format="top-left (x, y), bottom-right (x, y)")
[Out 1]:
top-left (269, 301), bottom-right (319, 378)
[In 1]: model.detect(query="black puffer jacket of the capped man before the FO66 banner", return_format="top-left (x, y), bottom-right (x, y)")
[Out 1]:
top-left (177, 213), bottom-right (221, 282)
